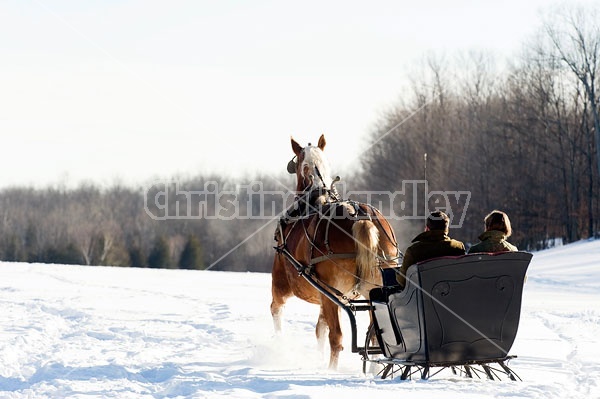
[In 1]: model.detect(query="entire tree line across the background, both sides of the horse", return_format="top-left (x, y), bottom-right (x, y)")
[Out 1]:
top-left (0, 3), bottom-right (600, 272)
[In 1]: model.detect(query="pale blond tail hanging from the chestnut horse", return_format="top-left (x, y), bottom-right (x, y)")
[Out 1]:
top-left (352, 220), bottom-right (379, 286)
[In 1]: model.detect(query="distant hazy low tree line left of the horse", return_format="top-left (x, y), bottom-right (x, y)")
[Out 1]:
top-left (0, 175), bottom-right (289, 271)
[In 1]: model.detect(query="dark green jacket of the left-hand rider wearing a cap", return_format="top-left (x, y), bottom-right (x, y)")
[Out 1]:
top-left (396, 230), bottom-right (465, 288)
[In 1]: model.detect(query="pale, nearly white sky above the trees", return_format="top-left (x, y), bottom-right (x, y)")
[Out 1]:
top-left (0, 0), bottom-right (592, 187)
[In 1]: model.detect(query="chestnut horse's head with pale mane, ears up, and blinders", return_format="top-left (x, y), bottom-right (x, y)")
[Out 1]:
top-left (288, 135), bottom-right (333, 192)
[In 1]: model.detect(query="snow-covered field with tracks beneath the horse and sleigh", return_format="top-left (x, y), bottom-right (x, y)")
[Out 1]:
top-left (0, 241), bottom-right (600, 399)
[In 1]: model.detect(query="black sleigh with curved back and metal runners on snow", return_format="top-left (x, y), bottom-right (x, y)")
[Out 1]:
top-left (363, 252), bottom-right (532, 380)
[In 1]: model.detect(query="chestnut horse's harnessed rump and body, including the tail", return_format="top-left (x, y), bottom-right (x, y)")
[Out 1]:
top-left (282, 201), bottom-right (397, 295)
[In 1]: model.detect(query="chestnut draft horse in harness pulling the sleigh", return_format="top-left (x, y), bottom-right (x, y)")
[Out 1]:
top-left (271, 135), bottom-right (400, 369)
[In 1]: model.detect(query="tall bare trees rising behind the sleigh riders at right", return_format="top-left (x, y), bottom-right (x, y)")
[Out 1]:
top-left (363, 3), bottom-right (600, 250)
